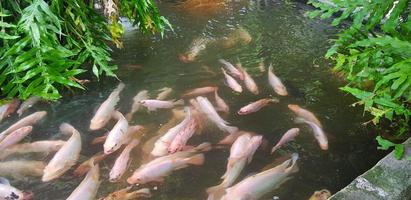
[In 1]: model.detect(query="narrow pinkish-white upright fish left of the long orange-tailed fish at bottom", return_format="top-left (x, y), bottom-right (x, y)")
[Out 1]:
top-left (109, 139), bottom-right (140, 182)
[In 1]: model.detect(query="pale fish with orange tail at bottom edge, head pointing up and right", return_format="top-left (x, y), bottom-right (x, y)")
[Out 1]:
top-left (207, 134), bottom-right (262, 200)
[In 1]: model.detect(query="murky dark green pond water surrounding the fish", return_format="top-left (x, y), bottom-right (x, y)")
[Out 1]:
top-left (0, 1), bottom-right (383, 200)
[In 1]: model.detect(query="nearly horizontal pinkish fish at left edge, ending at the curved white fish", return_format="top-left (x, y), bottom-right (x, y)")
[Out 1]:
top-left (0, 140), bottom-right (66, 160)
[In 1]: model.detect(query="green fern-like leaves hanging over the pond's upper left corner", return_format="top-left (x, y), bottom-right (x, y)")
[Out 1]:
top-left (0, 0), bottom-right (169, 100)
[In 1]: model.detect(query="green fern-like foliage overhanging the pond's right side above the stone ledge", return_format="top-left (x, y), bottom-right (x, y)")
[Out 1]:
top-left (308, 0), bottom-right (411, 158)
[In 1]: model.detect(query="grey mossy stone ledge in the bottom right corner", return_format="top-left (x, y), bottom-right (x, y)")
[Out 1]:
top-left (329, 138), bottom-right (411, 200)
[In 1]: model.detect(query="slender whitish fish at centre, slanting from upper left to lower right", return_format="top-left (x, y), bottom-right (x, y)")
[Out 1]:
top-left (196, 96), bottom-right (238, 133)
